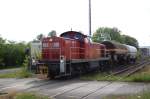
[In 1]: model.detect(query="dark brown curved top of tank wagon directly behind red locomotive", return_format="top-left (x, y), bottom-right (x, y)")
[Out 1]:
top-left (102, 41), bottom-right (127, 49)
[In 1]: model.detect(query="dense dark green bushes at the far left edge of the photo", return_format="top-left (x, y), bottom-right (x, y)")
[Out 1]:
top-left (0, 37), bottom-right (27, 68)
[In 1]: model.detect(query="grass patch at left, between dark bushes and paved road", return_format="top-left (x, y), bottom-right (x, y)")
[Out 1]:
top-left (0, 67), bottom-right (32, 78)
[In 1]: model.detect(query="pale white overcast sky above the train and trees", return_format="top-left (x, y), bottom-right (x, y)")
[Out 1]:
top-left (0, 0), bottom-right (150, 46)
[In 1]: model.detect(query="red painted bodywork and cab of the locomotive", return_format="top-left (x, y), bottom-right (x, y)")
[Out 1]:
top-left (42, 31), bottom-right (106, 61)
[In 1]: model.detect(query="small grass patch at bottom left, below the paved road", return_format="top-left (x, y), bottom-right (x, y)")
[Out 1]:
top-left (14, 93), bottom-right (49, 99)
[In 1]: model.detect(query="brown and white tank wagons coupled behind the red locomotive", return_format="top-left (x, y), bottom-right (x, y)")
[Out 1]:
top-left (102, 41), bottom-right (137, 64)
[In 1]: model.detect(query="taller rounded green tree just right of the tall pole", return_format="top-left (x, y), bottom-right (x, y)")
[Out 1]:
top-left (92, 27), bottom-right (122, 43)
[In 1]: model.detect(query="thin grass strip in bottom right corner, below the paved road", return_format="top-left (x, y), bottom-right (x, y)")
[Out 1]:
top-left (103, 92), bottom-right (150, 99)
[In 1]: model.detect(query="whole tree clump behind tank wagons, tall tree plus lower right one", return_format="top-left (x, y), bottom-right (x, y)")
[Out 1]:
top-left (92, 27), bottom-right (138, 48)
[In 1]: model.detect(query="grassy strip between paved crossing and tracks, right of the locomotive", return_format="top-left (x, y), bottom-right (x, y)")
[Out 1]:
top-left (81, 65), bottom-right (150, 82)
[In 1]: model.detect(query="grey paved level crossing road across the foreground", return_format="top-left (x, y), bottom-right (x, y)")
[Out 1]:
top-left (0, 78), bottom-right (150, 99)
